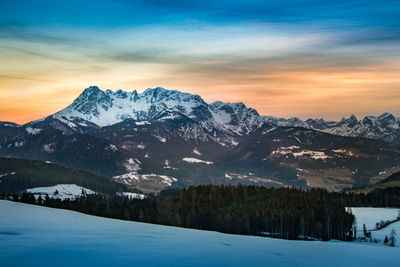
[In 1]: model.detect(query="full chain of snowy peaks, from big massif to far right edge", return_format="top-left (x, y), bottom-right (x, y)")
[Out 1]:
top-left (24, 86), bottom-right (400, 145)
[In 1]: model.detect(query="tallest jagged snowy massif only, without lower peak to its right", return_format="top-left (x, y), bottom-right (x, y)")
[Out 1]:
top-left (53, 86), bottom-right (211, 127)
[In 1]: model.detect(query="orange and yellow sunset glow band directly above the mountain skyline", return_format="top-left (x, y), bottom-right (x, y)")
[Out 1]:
top-left (0, 60), bottom-right (400, 124)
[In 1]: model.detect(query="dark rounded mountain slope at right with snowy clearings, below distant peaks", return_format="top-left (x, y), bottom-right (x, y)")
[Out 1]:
top-left (230, 125), bottom-right (400, 190)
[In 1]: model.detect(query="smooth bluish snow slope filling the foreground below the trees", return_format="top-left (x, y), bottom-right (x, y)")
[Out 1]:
top-left (0, 200), bottom-right (399, 266)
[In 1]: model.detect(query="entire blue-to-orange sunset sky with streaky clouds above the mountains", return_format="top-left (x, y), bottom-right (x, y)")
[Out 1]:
top-left (0, 0), bottom-right (400, 123)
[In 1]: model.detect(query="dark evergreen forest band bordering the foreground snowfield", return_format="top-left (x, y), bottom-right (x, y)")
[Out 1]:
top-left (4, 185), bottom-right (354, 243)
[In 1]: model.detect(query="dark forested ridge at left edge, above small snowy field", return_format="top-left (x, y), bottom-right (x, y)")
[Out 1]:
top-left (0, 158), bottom-right (127, 194)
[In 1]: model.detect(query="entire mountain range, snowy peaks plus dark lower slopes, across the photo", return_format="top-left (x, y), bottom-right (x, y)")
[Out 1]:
top-left (0, 86), bottom-right (400, 192)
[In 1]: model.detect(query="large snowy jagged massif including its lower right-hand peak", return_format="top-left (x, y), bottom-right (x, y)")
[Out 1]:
top-left (48, 86), bottom-right (263, 141)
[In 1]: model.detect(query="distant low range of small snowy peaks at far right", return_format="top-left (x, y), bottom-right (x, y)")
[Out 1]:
top-left (264, 113), bottom-right (400, 144)
